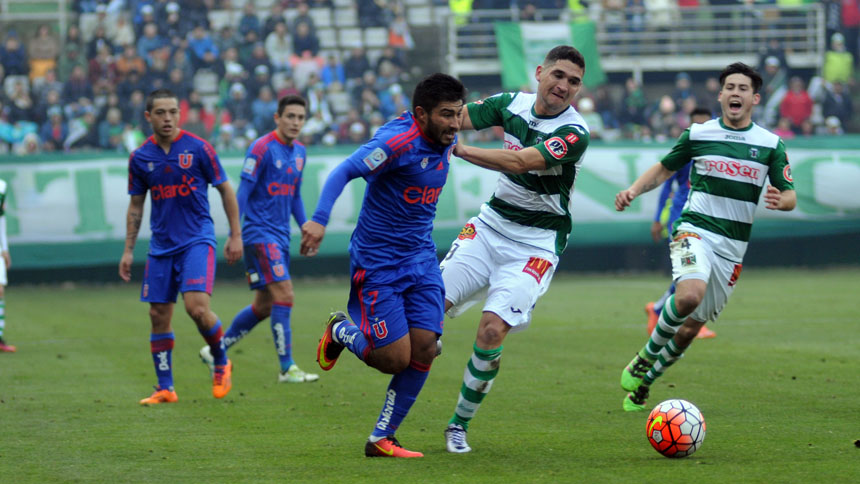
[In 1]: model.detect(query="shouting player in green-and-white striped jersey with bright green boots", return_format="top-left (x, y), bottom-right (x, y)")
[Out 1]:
top-left (615, 62), bottom-right (797, 411)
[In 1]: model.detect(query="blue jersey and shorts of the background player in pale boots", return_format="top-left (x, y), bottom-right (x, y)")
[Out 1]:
top-left (238, 131), bottom-right (307, 289)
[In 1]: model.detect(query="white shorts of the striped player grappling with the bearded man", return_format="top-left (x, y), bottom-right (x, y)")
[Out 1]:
top-left (440, 217), bottom-right (558, 332)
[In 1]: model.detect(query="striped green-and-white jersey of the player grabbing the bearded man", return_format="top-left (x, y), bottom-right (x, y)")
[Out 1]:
top-left (468, 92), bottom-right (590, 255)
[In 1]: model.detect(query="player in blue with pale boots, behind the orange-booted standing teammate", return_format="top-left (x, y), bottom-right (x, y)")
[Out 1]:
top-left (200, 95), bottom-right (319, 383)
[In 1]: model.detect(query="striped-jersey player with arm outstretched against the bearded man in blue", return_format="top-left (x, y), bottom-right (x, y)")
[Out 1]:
top-left (441, 46), bottom-right (589, 453)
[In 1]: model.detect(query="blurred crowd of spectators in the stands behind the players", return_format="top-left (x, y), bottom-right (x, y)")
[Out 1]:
top-left (0, 0), bottom-right (860, 154)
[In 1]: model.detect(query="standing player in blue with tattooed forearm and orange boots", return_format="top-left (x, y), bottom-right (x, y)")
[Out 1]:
top-left (119, 89), bottom-right (242, 405)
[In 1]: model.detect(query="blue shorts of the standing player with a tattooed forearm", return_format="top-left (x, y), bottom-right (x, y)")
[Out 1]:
top-left (140, 244), bottom-right (215, 303)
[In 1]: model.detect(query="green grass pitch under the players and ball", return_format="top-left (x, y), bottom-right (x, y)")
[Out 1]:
top-left (0, 268), bottom-right (860, 484)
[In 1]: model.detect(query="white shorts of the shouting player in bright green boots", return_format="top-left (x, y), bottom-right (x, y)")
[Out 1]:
top-left (669, 232), bottom-right (743, 321)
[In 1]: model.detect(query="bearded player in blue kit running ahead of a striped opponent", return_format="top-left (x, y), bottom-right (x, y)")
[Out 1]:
top-left (301, 74), bottom-right (466, 457)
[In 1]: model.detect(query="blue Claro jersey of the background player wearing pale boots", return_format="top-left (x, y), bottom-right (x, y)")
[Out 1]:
top-left (239, 131), bottom-right (307, 247)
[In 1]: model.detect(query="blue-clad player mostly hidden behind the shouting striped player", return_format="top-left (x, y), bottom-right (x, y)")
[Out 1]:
top-left (645, 107), bottom-right (717, 339)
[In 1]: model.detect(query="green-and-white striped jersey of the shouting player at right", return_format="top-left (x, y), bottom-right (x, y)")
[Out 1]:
top-left (661, 118), bottom-right (794, 263)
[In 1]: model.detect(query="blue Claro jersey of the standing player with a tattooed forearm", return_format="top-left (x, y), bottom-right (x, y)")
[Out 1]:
top-left (128, 130), bottom-right (227, 256)
